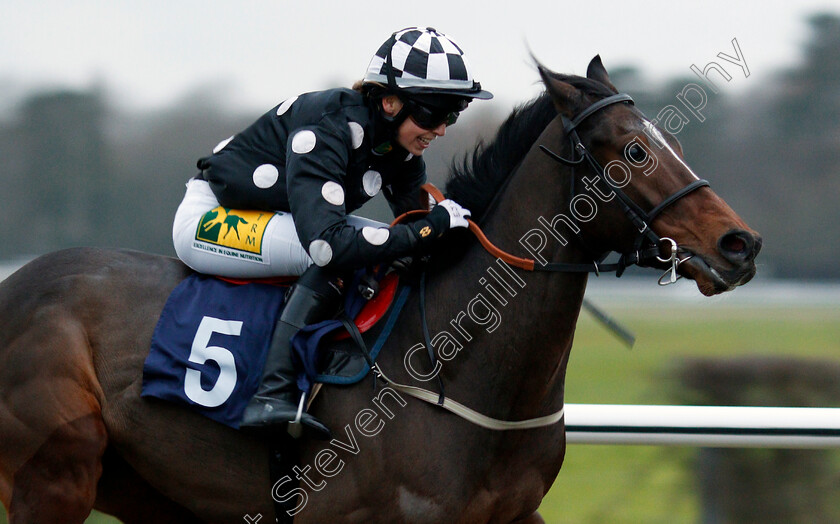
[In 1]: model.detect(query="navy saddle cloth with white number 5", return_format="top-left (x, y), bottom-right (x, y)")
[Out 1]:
top-left (141, 274), bottom-right (409, 428)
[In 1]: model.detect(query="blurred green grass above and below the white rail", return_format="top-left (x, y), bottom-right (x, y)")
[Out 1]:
top-left (541, 292), bottom-right (840, 524)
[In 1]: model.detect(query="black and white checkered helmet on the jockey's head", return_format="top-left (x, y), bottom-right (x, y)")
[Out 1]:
top-left (363, 27), bottom-right (493, 100)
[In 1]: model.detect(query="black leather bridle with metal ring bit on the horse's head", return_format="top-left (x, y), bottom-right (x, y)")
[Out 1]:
top-left (534, 93), bottom-right (709, 285)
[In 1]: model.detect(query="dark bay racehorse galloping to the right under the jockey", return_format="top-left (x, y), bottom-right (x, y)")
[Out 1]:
top-left (0, 57), bottom-right (761, 524)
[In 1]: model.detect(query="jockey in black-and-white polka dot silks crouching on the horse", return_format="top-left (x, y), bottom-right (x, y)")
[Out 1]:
top-left (172, 27), bottom-right (493, 438)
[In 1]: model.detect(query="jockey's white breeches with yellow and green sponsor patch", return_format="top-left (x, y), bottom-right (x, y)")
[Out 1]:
top-left (172, 179), bottom-right (386, 278)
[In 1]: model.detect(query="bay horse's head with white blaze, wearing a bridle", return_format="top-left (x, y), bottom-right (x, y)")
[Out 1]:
top-left (539, 56), bottom-right (761, 296)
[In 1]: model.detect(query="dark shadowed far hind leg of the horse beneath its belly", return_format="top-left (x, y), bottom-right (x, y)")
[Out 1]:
top-left (95, 448), bottom-right (201, 524)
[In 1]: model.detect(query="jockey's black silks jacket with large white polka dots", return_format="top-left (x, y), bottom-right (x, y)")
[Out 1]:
top-left (199, 89), bottom-right (426, 268)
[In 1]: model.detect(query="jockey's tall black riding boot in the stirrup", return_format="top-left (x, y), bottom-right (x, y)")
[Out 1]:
top-left (240, 266), bottom-right (342, 440)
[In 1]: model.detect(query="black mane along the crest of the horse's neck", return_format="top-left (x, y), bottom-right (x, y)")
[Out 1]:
top-left (446, 73), bottom-right (614, 221)
